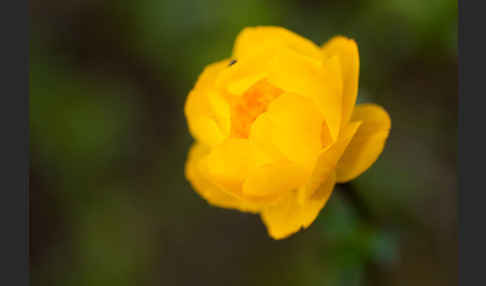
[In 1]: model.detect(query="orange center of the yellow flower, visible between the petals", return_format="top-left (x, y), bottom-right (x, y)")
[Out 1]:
top-left (230, 80), bottom-right (283, 138)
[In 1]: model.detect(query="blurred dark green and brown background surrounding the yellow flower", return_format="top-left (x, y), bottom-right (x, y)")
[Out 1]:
top-left (30, 0), bottom-right (458, 286)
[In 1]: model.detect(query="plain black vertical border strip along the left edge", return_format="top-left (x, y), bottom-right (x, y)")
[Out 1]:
top-left (0, 1), bottom-right (30, 286)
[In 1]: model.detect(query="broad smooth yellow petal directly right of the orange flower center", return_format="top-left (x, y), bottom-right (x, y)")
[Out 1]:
top-left (267, 94), bottom-right (323, 168)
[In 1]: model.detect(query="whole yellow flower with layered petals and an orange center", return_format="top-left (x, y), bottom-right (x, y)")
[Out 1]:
top-left (185, 27), bottom-right (391, 239)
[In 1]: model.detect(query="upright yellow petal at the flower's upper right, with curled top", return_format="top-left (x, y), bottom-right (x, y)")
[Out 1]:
top-left (322, 36), bottom-right (359, 130)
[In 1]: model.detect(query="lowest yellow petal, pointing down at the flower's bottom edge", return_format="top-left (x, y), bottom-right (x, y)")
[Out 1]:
top-left (261, 173), bottom-right (335, 239)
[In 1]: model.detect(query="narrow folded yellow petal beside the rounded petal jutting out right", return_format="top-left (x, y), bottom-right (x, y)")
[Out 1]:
top-left (298, 121), bottom-right (361, 204)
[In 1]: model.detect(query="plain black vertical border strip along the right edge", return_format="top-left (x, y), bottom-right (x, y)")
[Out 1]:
top-left (458, 0), bottom-right (486, 285)
